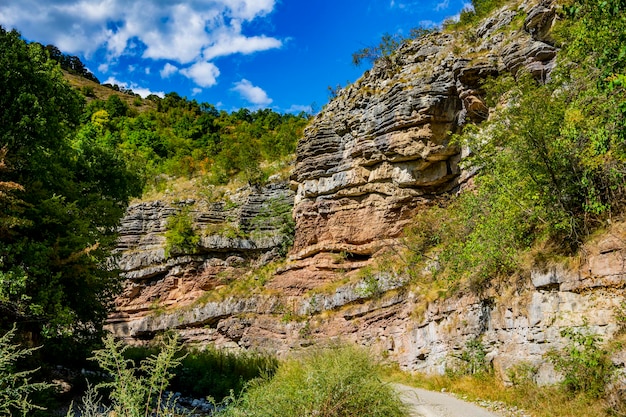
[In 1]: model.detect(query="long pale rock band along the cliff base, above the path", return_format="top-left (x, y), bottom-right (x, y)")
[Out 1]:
top-left (111, 224), bottom-right (626, 383)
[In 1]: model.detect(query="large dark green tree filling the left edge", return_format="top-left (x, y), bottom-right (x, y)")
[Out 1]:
top-left (0, 27), bottom-right (140, 358)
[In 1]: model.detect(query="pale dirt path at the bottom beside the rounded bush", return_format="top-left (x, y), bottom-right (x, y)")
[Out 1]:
top-left (393, 384), bottom-right (500, 417)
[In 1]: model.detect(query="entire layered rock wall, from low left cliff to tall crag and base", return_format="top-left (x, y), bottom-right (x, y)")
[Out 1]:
top-left (108, 1), bottom-right (626, 381)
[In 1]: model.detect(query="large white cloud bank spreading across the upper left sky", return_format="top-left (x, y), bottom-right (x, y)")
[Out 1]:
top-left (0, 0), bottom-right (281, 64)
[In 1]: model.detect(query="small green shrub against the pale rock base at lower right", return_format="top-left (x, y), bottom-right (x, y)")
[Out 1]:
top-left (547, 326), bottom-right (617, 398)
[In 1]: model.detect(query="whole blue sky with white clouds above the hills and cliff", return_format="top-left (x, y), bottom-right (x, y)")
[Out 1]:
top-left (0, 0), bottom-right (468, 113)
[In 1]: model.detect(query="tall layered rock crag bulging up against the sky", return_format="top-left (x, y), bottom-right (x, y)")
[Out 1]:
top-left (292, 2), bottom-right (557, 259)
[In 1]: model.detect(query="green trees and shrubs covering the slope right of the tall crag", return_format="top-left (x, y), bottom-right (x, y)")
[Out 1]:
top-left (398, 1), bottom-right (626, 291)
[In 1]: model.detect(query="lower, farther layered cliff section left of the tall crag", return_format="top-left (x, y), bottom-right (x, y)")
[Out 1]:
top-left (109, 183), bottom-right (293, 323)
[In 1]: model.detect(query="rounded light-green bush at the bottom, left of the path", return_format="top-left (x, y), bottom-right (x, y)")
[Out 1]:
top-left (220, 347), bottom-right (407, 417)
